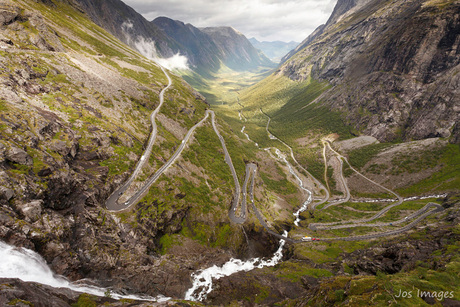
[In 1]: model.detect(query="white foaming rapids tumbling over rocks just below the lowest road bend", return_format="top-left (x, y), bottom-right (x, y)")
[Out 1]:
top-left (185, 231), bottom-right (288, 301)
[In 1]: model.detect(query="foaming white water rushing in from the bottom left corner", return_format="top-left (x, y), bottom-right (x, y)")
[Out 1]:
top-left (0, 241), bottom-right (169, 302)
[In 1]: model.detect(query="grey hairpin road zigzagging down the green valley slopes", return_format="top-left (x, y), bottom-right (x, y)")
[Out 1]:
top-left (106, 66), bottom-right (443, 243)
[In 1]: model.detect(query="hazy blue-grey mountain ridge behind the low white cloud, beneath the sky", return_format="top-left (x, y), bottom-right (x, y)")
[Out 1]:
top-left (70, 0), bottom-right (274, 75)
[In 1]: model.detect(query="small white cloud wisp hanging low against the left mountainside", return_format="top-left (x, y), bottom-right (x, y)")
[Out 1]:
top-left (121, 21), bottom-right (189, 70)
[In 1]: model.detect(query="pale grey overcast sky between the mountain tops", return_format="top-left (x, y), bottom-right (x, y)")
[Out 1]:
top-left (123, 0), bottom-right (337, 42)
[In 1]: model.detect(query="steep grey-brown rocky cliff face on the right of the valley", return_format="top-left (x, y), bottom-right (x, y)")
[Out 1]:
top-left (278, 0), bottom-right (460, 143)
